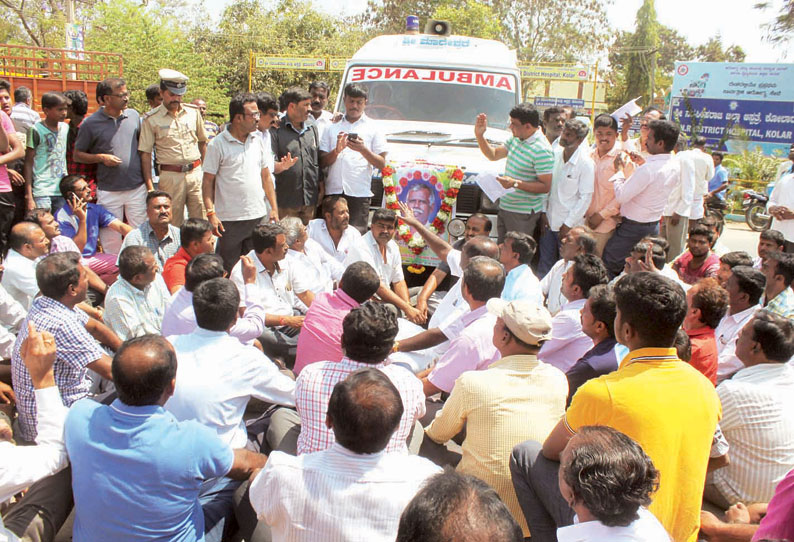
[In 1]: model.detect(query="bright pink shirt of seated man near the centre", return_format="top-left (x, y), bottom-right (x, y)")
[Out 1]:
top-left (293, 289), bottom-right (359, 375)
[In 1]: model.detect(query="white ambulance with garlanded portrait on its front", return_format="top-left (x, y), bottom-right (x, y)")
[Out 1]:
top-left (336, 26), bottom-right (521, 237)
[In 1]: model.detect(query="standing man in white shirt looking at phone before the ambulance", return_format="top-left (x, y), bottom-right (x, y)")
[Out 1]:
top-left (320, 83), bottom-right (386, 233)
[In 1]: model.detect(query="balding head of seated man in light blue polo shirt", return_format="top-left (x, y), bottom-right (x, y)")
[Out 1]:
top-left (111, 335), bottom-right (176, 406)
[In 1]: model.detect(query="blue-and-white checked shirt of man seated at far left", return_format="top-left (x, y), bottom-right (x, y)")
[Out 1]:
top-left (11, 297), bottom-right (105, 441)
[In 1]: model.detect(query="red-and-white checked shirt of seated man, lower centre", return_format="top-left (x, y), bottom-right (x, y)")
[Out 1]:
top-left (295, 357), bottom-right (425, 455)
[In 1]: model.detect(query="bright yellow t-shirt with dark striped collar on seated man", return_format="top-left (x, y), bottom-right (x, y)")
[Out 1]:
top-left (565, 348), bottom-right (722, 542)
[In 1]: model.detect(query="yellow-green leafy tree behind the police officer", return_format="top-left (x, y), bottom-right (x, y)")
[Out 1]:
top-left (86, 0), bottom-right (228, 118)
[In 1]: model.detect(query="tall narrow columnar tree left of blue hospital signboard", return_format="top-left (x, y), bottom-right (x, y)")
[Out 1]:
top-left (623, 0), bottom-right (659, 105)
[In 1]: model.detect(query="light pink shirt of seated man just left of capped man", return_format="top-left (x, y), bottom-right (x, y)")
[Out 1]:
top-left (427, 306), bottom-right (502, 393)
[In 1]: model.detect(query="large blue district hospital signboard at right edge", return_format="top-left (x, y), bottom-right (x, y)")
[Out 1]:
top-left (670, 62), bottom-right (794, 155)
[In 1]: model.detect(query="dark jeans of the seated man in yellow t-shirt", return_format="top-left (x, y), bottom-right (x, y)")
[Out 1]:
top-left (510, 440), bottom-right (574, 542)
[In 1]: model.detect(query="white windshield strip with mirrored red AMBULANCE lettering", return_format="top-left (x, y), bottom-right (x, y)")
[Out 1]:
top-left (348, 66), bottom-right (515, 92)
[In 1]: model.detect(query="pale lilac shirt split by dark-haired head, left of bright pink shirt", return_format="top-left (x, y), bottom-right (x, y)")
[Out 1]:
top-left (162, 284), bottom-right (266, 344)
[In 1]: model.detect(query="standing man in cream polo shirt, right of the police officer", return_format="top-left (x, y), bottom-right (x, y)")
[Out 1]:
top-left (202, 93), bottom-right (278, 272)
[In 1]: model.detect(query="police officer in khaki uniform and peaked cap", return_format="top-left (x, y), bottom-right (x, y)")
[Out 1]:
top-left (138, 70), bottom-right (207, 227)
